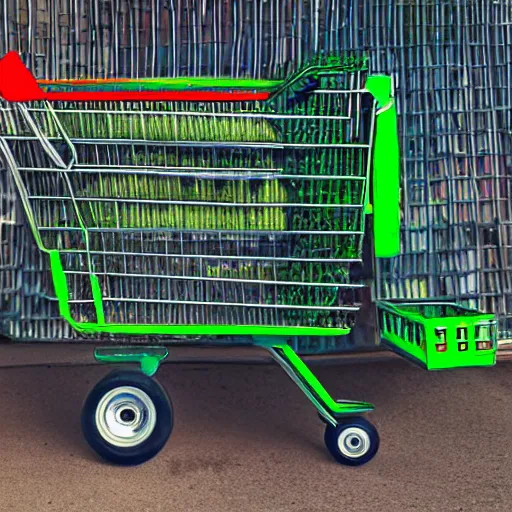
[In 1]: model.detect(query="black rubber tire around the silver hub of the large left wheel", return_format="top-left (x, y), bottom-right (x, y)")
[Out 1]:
top-left (82, 371), bottom-right (174, 466)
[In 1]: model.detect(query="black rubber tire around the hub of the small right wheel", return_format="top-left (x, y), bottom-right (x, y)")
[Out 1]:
top-left (324, 417), bottom-right (380, 466)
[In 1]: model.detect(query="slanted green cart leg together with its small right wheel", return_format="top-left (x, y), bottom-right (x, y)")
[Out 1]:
top-left (255, 339), bottom-right (380, 466)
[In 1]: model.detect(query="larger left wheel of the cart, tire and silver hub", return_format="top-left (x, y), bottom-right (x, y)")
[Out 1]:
top-left (82, 371), bottom-right (173, 466)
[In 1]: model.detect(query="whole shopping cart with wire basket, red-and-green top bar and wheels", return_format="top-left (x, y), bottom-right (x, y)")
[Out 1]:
top-left (0, 53), bottom-right (494, 465)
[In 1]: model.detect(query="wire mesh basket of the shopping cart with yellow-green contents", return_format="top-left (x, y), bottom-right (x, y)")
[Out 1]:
top-left (1, 68), bottom-right (373, 329)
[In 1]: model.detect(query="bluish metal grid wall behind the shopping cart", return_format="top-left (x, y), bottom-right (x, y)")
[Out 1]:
top-left (0, 0), bottom-right (512, 351)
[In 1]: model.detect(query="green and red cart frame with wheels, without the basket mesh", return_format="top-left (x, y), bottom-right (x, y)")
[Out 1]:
top-left (0, 55), bottom-right (400, 465)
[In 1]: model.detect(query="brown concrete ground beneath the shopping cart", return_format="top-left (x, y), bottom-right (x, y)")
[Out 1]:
top-left (0, 348), bottom-right (512, 512)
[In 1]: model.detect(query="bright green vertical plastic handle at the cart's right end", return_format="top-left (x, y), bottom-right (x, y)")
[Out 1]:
top-left (366, 75), bottom-right (400, 258)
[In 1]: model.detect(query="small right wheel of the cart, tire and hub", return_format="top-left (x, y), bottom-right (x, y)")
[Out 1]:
top-left (324, 418), bottom-right (379, 466)
